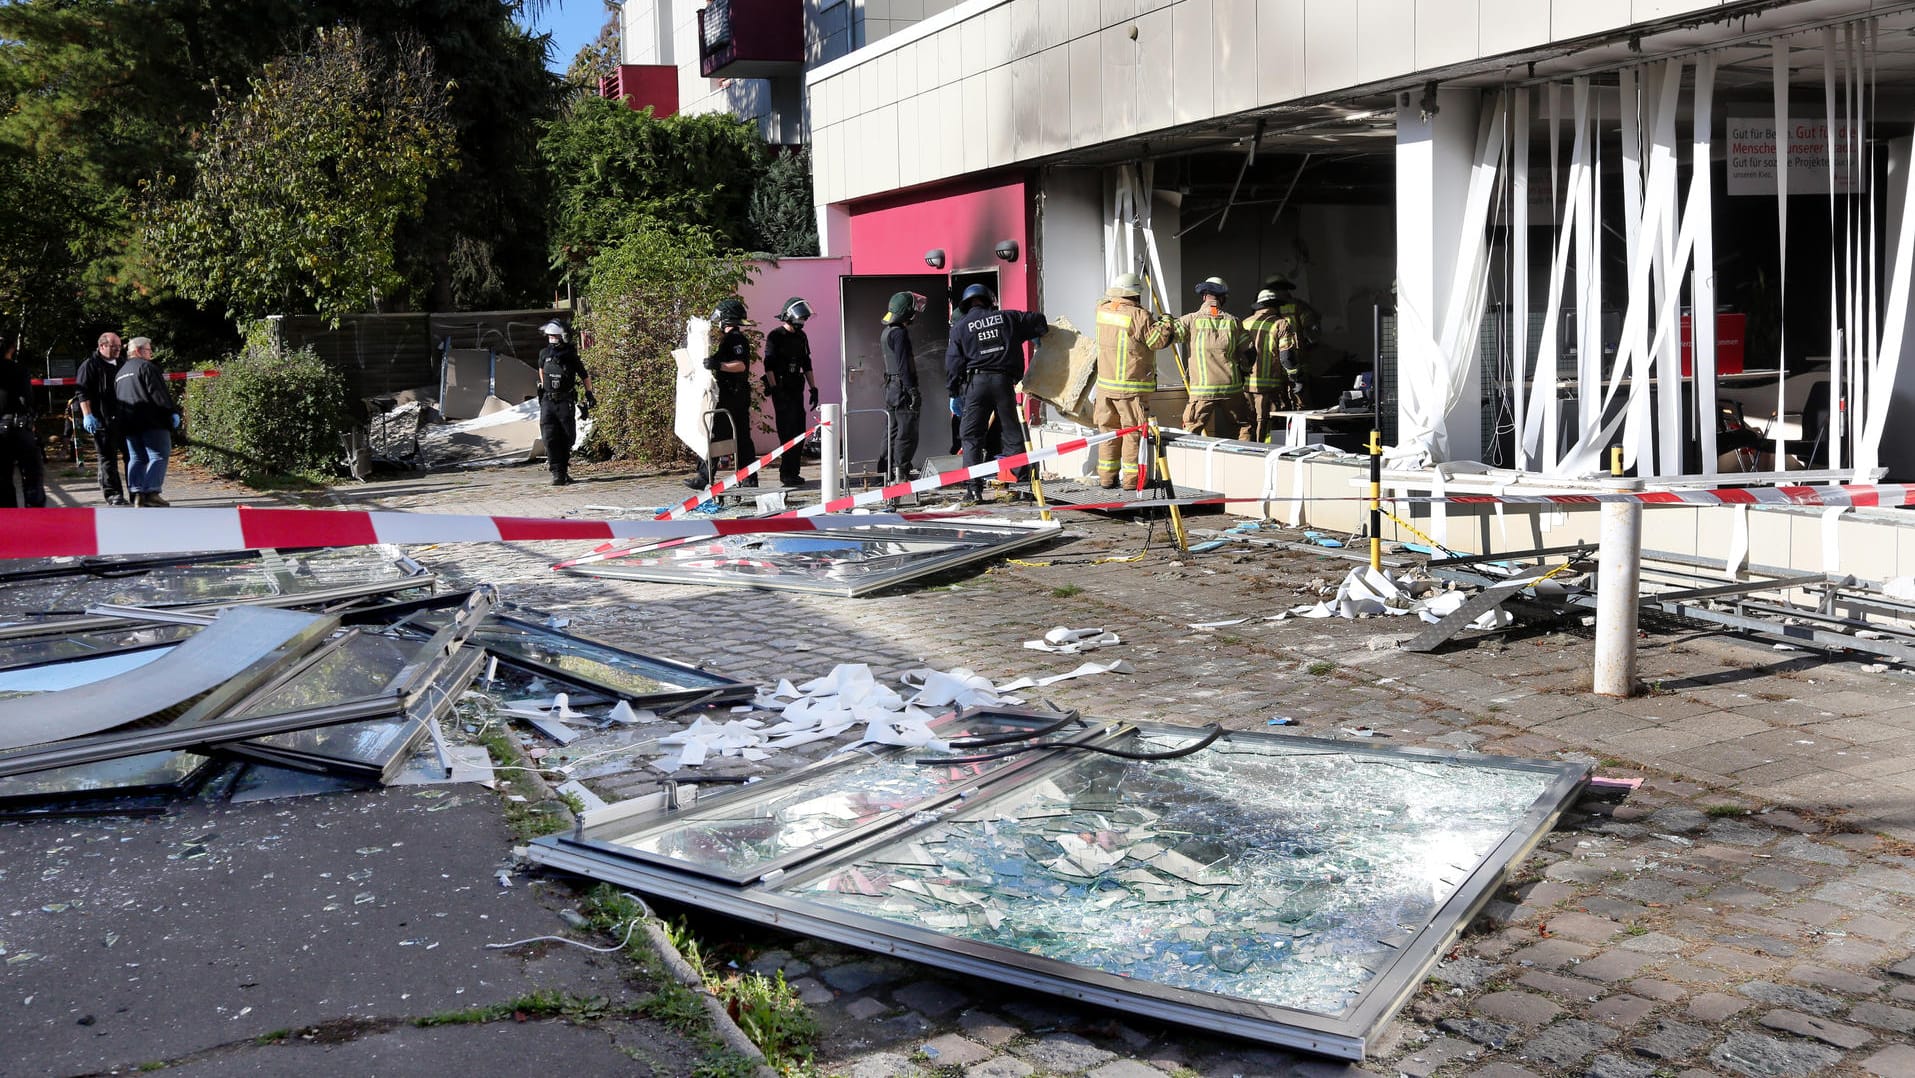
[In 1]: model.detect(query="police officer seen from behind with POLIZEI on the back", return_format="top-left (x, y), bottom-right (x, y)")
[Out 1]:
top-left (944, 285), bottom-right (1051, 500)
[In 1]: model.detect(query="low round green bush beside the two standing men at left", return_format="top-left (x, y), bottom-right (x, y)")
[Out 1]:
top-left (186, 331), bottom-right (352, 483)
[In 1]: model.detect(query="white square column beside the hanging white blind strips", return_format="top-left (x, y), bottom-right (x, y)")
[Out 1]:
top-left (1396, 90), bottom-right (1482, 460)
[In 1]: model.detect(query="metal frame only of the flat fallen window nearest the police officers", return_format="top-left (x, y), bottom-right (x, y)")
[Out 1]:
top-left (561, 521), bottom-right (1063, 599)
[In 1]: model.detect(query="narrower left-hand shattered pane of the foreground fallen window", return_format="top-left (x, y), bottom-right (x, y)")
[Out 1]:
top-left (584, 716), bottom-right (1064, 876)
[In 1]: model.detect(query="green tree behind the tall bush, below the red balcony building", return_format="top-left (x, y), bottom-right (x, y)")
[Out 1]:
top-left (540, 98), bottom-right (764, 278)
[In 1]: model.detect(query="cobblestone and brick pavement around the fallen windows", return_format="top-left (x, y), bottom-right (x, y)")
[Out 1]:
top-left (26, 457), bottom-right (1915, 1078)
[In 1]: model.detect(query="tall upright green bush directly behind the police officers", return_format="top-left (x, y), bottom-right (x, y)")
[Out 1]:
top-left (584, 218), bottom-right (751, 463)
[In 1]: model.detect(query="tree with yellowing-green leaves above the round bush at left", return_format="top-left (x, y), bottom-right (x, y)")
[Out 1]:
top-left (142, 25), bottom-right (454, 322)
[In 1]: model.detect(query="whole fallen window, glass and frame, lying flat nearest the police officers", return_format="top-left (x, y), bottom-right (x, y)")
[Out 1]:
top-left (565, 521), bottom-right (1057, 595)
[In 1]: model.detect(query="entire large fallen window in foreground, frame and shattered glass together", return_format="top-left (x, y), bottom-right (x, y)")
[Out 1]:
top-left (532, 716), bottom-right (1588, 1059)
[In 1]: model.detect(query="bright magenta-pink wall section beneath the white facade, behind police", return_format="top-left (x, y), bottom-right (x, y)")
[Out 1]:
top-left (850, 174), bottom-right (1034, 308)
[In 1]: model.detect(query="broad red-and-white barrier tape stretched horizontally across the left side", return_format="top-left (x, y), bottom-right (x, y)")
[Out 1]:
top-left (0, 507), bottom-right (926, 557)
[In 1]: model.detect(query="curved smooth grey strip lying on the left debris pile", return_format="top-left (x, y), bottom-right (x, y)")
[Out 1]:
top-left (0, 607), bottom-right (339, 749)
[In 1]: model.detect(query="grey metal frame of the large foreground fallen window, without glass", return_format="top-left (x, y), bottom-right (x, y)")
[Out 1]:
top-left (530, 708), bottom-right (1589, 1061)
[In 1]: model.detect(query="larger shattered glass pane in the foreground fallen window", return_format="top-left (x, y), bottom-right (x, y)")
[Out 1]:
top-left (777, 733), bottom-right (1555, 1017)
